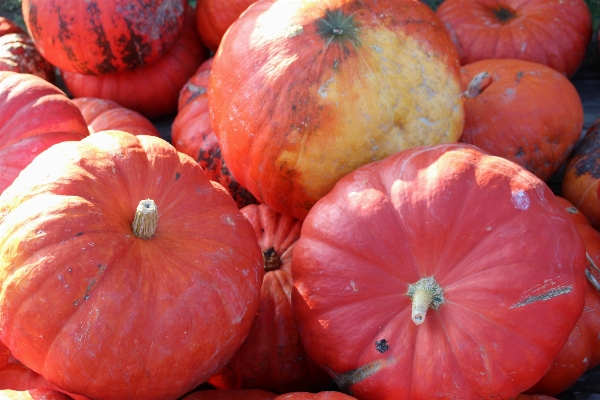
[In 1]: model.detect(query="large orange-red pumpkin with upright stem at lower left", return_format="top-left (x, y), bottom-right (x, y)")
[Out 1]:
top-left (0, 131), bottom-right (264, 399)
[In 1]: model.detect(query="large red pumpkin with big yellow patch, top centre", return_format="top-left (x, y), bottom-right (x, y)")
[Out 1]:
top-left (208, 0), bottom-right (464, 220)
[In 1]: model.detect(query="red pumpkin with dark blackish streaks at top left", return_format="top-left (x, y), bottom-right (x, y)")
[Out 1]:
top-left (22, 0), bottom-right (187, 75)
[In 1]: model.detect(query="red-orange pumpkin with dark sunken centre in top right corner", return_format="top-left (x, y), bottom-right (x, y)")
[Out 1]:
top-left (436, 0), bottom-right (592, 77)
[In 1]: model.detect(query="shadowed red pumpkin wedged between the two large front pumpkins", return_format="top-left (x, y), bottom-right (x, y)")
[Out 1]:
top-left (208, 204), bottom-right (333, 393)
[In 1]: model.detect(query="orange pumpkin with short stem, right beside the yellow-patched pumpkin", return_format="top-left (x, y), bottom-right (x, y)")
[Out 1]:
top-left (460, 59), bottom-right (584, 181)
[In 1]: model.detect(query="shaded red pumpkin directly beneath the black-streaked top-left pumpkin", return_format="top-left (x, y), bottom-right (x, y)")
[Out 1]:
top-left (60, 8), bottom-right (206, 119)
